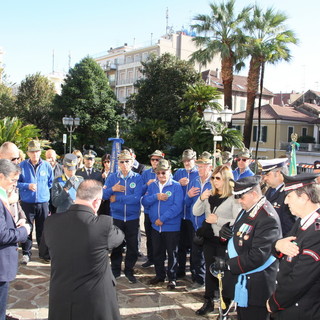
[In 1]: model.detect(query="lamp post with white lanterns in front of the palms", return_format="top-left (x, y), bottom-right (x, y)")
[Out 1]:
top-left (203, 106), bottom-right (233, 168)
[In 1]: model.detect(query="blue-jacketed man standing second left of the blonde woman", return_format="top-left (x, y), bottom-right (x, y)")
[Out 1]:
top-left (173, 149), bottom-right (199, 278)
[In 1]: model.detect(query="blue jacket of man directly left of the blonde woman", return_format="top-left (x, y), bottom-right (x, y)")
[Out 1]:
top-left (184, 175), bottom-right (212, 230)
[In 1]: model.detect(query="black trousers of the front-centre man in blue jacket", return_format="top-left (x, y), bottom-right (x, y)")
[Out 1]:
top-left (152, 229), bottom-right (180, 281)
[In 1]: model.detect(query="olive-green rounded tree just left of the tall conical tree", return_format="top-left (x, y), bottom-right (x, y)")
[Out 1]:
top-left (15, 73), bottom-right (56, 139)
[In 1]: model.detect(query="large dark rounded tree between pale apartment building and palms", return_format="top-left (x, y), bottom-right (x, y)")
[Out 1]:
top-left (126, 53), bottom-right (200, 134)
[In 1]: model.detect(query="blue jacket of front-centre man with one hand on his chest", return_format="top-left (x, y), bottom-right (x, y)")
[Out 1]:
top-left (142, 178), bottom-right (183, 232)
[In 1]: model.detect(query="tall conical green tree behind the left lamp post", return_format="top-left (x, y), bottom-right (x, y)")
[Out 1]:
top-left (56, 57), bottom-right (123, 148)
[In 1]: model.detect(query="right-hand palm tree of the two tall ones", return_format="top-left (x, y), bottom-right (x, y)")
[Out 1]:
top-left (244, 6), bottom-right (298, 148)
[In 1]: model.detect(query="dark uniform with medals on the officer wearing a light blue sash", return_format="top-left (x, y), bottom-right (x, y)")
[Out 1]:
top-left (223, 198), bottom-right (281, 306)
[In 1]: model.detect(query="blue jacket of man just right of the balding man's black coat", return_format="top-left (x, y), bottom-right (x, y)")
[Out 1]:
top-left (103, 171), bottom-right (142, 221)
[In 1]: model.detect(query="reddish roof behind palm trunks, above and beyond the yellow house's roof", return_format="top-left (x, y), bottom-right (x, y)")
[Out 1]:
top-left (202, 70), bottom-right (273, 96)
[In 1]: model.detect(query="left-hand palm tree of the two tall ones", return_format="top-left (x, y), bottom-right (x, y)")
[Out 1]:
top-left (191, 0), bottom-right (251, 110)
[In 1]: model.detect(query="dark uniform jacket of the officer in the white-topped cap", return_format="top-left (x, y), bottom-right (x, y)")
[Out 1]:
top-left (265, 186), bottom-right (296, 237)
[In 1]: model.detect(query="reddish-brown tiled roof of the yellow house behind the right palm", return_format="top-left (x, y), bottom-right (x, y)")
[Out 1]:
top-left (232, 104), bottom-right (316, 123)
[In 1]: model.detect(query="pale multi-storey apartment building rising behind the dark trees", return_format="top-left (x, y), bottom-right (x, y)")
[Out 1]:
top-left (94, 32), bottom-right (221, 104)
